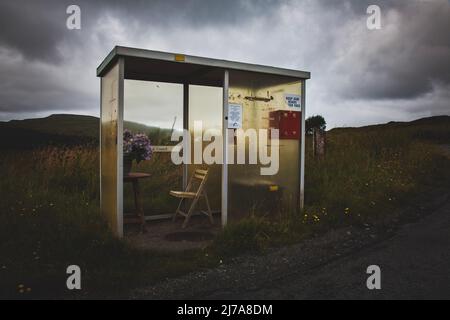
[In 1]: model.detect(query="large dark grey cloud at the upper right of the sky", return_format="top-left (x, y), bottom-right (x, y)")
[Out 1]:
top-left (337, 1), bottom-right (450, 99)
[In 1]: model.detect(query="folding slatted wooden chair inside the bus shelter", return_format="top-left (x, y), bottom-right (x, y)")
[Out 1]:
top-left (170, 169), bottom-right (214, 229)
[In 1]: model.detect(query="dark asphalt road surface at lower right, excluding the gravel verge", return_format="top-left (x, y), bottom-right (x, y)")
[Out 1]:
top-left (256, 195), bottom-right (450, 299)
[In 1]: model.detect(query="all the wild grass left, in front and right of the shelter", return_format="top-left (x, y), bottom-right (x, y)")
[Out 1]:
top-left (0, 119), bottom-right (450, 298)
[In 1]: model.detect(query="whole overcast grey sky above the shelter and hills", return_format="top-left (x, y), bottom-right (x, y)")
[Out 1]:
top-left (0, 0), bottom-right (450, 127)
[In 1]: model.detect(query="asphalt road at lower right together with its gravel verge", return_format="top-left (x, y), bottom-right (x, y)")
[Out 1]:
top-left (133, 194), bottom-right (450, 299)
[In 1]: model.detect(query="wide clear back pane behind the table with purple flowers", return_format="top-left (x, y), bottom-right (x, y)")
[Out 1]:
top-left (123, 80), bottom-right (183, 215)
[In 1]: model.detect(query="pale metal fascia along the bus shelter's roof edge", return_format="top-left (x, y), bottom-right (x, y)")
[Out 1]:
top-left (97, 46), bottom-right (311, 79)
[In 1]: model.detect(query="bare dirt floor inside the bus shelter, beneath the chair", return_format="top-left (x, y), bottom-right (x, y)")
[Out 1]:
top-left (124, 214), bottom-right (222, 252)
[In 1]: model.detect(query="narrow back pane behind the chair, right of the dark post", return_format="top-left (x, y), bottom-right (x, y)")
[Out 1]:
top-left (188, 85), bottom-right (223, 212)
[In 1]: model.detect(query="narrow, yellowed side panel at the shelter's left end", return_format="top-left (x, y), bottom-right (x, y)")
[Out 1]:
top-left (100, 60), bottom-right (122, 235)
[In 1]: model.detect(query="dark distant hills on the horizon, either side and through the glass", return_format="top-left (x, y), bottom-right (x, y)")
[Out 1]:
top-left (0, 114), bottom-right (450, 149)
